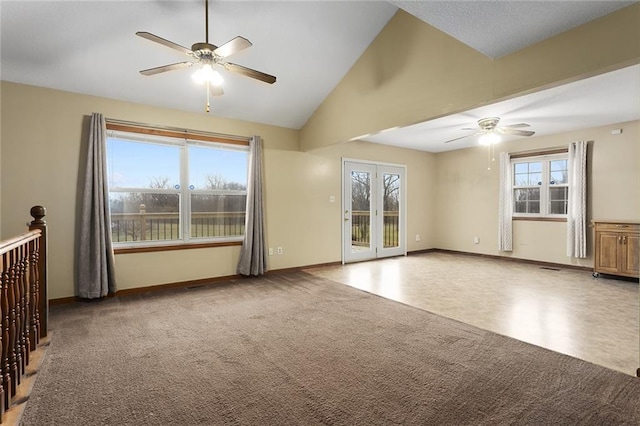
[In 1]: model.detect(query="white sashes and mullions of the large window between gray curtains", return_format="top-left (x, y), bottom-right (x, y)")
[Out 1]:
top-left (107, 130), bottom-right (249, 249)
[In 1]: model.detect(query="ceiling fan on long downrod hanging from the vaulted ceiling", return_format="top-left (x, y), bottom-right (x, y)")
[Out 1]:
top-left (136, 0), bottom-right (276, 112)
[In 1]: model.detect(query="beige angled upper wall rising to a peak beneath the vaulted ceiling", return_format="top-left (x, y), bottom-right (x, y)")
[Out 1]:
top-left (301, 10), bottom-right (493, 150)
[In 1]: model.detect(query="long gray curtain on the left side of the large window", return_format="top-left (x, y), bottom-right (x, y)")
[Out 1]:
top-left (77, 113), bottom-right (116, 299)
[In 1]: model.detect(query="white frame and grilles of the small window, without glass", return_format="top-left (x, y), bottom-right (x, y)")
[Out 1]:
top-left (509, 150), bottom-right (569, 221)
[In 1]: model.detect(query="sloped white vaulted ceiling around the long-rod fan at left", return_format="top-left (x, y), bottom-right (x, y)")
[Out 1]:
top-left (0, 0), bottom-right (397, 129)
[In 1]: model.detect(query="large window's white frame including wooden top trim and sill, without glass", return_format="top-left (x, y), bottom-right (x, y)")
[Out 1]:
top-left (106, 120), bottom-right (249, 253)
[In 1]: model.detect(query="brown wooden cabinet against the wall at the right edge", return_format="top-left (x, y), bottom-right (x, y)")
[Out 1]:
top-left (593, 220), bottom-right (640, 278)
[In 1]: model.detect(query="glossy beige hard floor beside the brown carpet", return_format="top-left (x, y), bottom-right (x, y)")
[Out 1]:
top-left (306, 252), bottom-right (640, 376)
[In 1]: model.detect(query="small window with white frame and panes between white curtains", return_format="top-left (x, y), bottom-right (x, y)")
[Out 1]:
top-left (512, 154), bottom-right (569, 217)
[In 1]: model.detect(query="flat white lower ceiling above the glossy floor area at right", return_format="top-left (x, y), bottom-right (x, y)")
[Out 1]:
top-left (359, 65), bottom-right (640, 152)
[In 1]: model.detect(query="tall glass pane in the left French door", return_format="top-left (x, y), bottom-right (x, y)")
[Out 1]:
top-left (351, 170), bottom-right (371, 253)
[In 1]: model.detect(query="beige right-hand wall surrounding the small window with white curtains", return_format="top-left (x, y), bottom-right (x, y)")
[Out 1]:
top-left (434, 121), bottom-right (640, 267)
